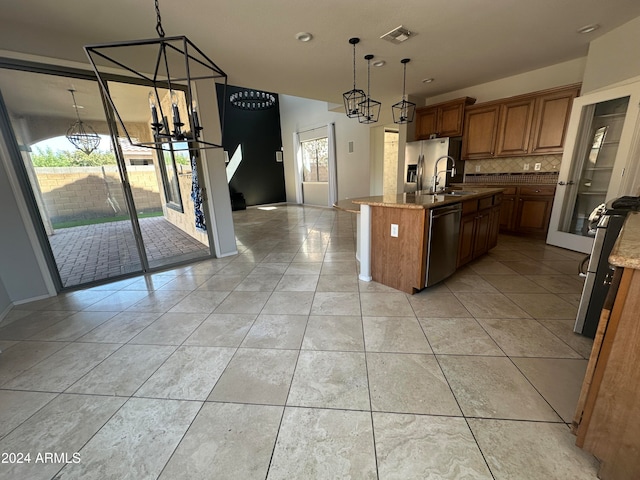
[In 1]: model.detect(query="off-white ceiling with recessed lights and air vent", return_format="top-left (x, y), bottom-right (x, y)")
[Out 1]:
top-left (0, 0), bottom-right (640, 122)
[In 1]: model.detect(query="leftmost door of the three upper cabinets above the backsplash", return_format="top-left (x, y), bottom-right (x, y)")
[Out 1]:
top-left (462, 104), bottom-right (500, 160)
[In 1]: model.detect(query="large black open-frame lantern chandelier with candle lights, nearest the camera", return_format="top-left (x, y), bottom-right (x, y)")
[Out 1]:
top-left (84, 0), bottom-right (227, 150)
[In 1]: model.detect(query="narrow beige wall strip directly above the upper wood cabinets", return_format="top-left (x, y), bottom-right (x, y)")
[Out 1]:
top-left (425, 57), bottom-right (587, 105)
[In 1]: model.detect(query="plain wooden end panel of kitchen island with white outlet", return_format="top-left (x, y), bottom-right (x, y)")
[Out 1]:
top-left (371, 206), bottom-right (427, 294)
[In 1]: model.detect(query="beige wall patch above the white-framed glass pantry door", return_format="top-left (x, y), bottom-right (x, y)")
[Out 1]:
top-left (582, 17), bottom-right (640, 93)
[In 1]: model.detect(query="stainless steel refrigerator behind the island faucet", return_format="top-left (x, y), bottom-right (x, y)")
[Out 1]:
top-left (404, 137), bottom-right (464, 193)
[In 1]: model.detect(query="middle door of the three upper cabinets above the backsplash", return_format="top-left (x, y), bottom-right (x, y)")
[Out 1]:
top-left (496, 98), bottom-right (536, 157)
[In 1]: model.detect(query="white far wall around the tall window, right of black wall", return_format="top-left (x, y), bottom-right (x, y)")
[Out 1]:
top-left (280, 95), bottom-right (377, 203)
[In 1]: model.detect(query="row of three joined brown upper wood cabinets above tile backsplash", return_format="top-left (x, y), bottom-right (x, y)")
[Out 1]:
top-left (462, 84), bottom-right (580, 160)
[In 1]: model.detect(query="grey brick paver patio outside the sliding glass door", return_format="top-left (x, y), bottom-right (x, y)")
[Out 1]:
top-left (49, 217), bottom-right (209, 287)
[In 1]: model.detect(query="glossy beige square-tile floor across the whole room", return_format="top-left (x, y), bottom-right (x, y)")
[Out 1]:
top-left (0, 205), bottom-right (598, 480)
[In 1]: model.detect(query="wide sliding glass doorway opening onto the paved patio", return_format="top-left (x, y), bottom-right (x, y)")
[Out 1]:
top-left (0, 63), bottom-right (211, 290)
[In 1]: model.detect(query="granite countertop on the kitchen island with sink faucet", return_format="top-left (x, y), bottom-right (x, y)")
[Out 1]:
top-left (344, 187), bottom-right (503, 211)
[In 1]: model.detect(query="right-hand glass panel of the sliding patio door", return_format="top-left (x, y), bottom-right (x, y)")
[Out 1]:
top-left (108, 82), bottom-right (211, 268)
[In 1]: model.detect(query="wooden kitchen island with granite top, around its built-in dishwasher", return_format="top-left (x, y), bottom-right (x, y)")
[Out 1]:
top-left (335, 188), bottom-right (502, 294)
